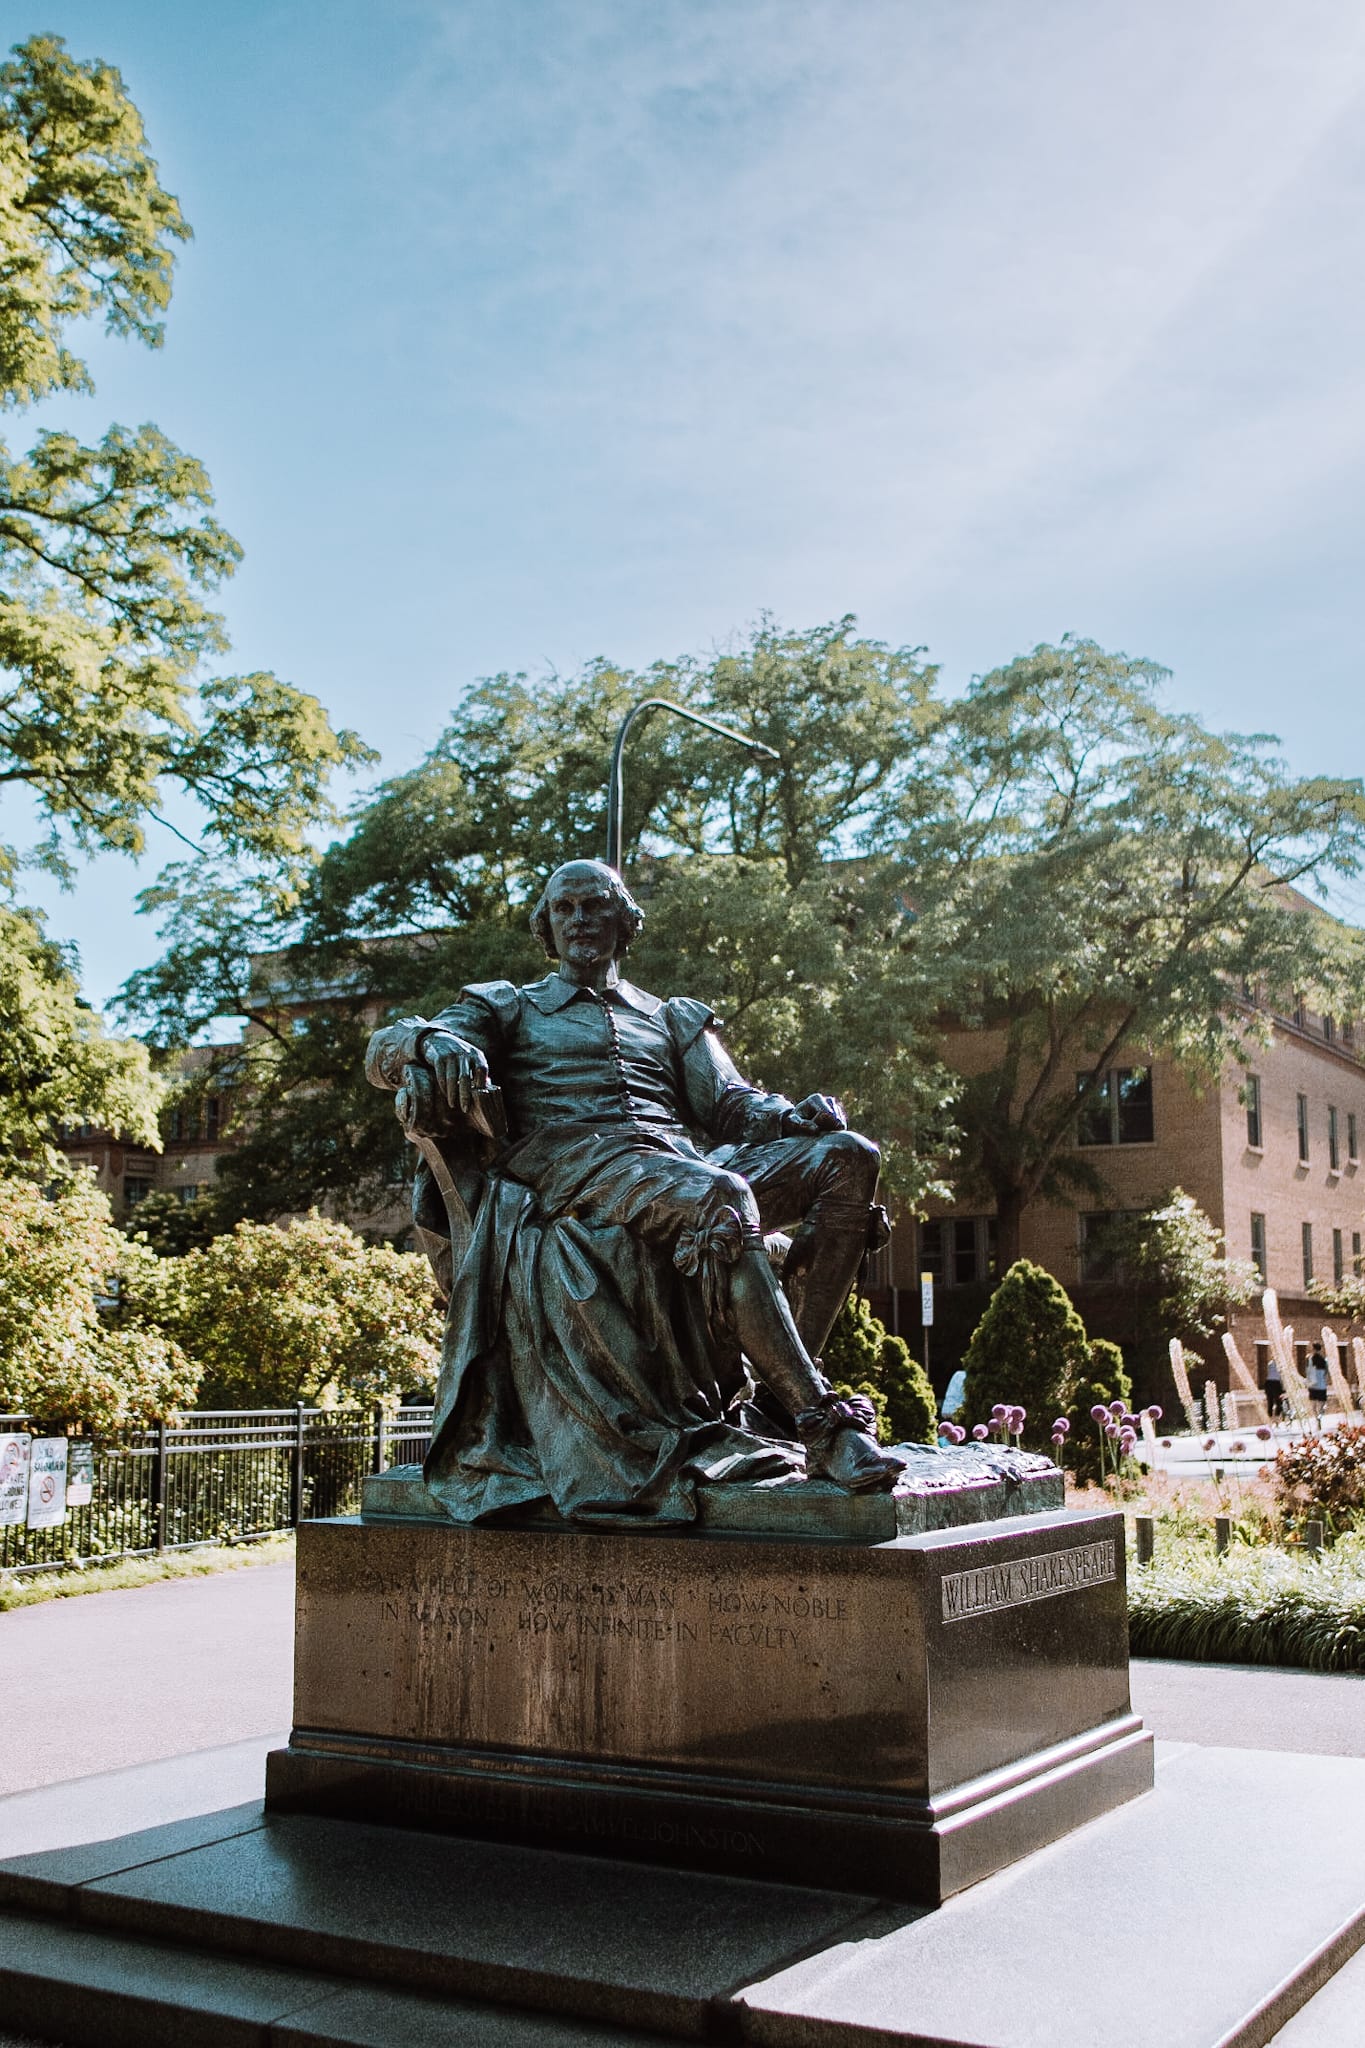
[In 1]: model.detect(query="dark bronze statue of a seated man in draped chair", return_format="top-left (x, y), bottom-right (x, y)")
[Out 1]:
top-left (366, 860), bottom-right (900, 1524)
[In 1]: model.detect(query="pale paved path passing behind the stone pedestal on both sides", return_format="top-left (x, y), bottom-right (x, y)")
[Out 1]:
top-left (0, 1565), bottom-right (1365, 1796)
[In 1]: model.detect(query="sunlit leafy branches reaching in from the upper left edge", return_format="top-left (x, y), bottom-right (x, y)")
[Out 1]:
top-left (0, 35), bottom-right (366, 1153)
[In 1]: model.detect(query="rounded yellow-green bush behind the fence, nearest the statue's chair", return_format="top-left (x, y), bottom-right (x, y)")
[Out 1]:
top-left (127, 1214), bottom-right (440, 1407)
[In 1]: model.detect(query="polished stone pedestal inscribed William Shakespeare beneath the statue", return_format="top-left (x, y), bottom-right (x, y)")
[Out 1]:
top-left (266, 1509), bottom-right (1152, 1903)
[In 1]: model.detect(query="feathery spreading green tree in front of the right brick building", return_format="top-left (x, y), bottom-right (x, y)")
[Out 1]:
top-left (900, 639), bottom-right (1365, 1264)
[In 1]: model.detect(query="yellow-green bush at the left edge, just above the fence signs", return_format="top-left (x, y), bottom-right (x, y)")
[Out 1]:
top-left (0, 1174), bottom-right (199, 1432)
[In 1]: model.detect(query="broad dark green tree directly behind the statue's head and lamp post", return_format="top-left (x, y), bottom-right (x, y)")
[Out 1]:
top-left (125, 618), bottom-right (950, 1214)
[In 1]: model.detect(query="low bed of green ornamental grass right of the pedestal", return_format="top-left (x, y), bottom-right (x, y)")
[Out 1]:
top-left (1128, 1532), bottom-right (1365, 1671)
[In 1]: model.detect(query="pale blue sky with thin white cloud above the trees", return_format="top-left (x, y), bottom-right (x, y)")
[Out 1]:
top-left (4, 0), bottom-right (1365, 999)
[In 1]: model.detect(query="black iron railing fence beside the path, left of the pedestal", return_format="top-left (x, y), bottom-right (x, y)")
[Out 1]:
top-left (0, 1403), bottom-right (432, 1571)
